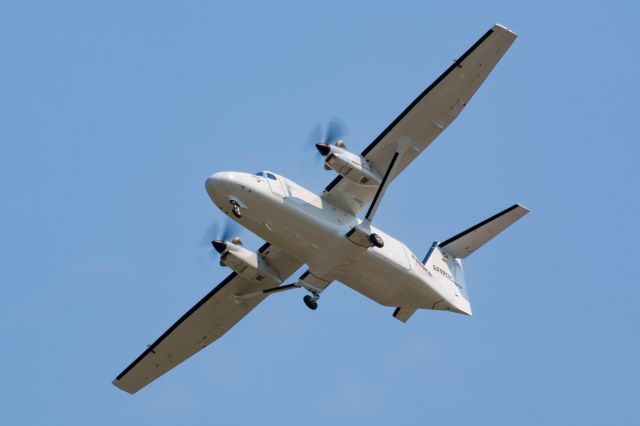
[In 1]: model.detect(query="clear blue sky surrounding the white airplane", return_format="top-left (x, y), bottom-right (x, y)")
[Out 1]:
top-left (0, 1), bottom-right (640, 426)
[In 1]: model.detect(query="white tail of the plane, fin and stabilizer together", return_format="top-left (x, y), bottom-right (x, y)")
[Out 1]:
top-left (423, 204), bottom-right (529, 315)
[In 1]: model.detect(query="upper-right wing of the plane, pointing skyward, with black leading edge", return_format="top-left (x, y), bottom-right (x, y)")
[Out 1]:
top-left (322, 24), bottom-right (516, 214)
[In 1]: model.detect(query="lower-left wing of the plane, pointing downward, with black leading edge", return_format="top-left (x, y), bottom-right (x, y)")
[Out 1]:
top-left (113, 243), bottom-right (302, 393)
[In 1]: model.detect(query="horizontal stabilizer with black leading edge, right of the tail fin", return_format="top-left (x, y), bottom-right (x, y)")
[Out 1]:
top-left (438, 204), bottom-right (529, 259)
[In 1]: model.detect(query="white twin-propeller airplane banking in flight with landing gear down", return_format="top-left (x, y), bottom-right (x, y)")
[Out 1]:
top-left (113, 24), bottom-right (529, 394)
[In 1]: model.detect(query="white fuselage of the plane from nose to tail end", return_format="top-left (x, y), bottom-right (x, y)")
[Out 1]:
top-left (206, 172), bottom-right (470, 314)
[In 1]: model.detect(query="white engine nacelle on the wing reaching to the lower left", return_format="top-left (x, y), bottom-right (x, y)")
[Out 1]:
top-left (220, 244), bottom-right (282, 287)
